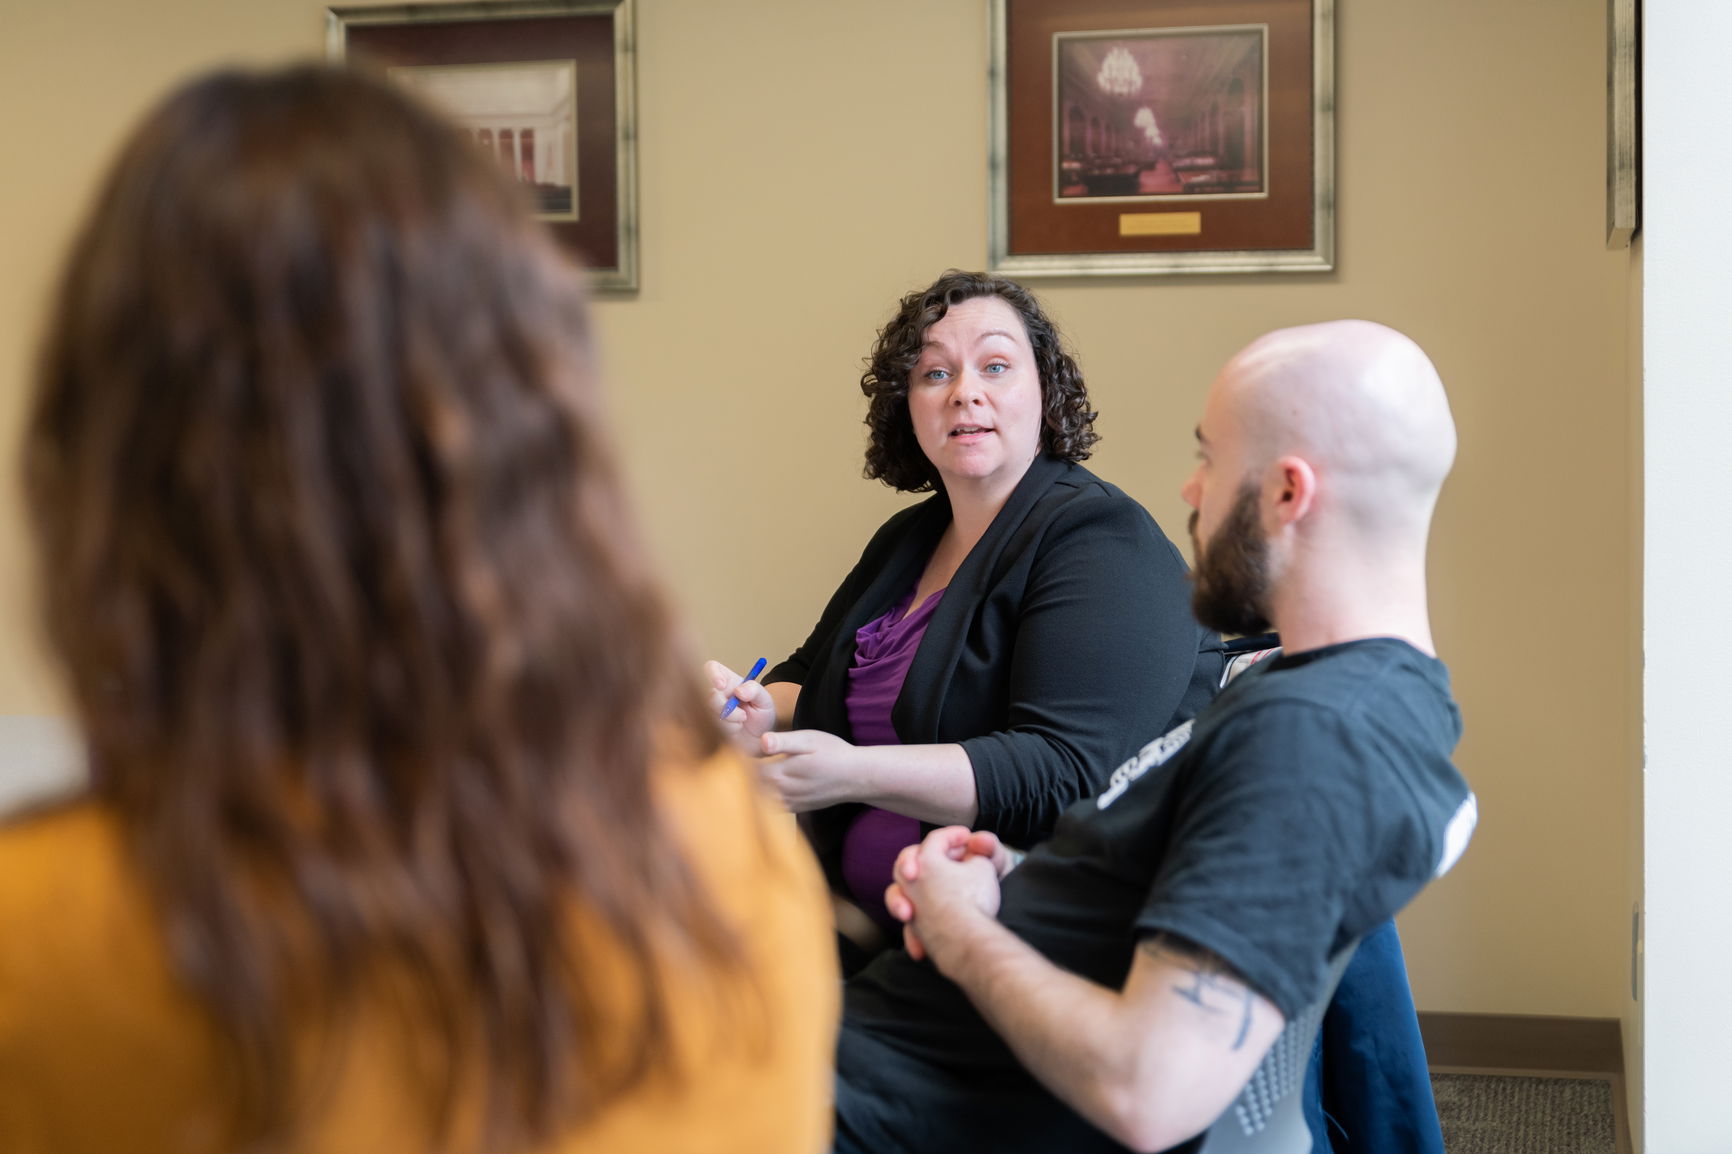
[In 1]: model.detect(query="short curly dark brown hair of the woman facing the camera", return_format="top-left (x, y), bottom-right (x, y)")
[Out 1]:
top-left (861, 269), bottom-right (1100, 492)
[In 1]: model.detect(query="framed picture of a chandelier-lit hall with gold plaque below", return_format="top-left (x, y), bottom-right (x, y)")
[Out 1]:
top-left (989, 0), bottom-right (1335, 277)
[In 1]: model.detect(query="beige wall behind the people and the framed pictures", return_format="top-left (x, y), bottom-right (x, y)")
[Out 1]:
top-left (0, 0), bottom-right (1637, 1017)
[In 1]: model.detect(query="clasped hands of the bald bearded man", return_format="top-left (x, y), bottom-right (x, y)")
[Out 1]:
top-left (883, 825), bottom-right (1015, 969)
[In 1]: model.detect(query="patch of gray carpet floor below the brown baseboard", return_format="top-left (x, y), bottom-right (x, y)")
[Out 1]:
top-left (1431, 1074), bottom-right (1618, 1154)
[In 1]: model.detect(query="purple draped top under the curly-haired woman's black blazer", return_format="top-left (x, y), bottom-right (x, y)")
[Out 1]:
top-left (842, 589), bottom-right (944, 929)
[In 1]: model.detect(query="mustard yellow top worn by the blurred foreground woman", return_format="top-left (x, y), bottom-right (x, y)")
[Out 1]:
top-left (0, 754), bottom-right (840, 1154)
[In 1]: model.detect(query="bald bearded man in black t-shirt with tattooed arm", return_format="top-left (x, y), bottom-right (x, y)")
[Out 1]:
top-left (837, 321), bottom-right (1476, 1154)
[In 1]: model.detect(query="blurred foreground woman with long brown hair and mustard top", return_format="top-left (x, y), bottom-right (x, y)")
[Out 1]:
top-left (0, 68), bottom-right (837, 1154)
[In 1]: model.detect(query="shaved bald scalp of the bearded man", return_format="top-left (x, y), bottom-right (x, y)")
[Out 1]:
top-left (1214, 321), bottom-right (1455, 530)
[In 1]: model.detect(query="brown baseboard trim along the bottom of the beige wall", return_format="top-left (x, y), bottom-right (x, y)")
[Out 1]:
top-left (1419, 1012), bottom-right (1623, 1078)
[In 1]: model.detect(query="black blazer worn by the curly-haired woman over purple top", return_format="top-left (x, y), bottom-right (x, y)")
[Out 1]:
top-left (764, 456), bottom-right (1223, 892)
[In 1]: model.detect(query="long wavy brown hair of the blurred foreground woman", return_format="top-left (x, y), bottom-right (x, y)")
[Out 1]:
top-left (24, 68), bottom-right (741, 1149)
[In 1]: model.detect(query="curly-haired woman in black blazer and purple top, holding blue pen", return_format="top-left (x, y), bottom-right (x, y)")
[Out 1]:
top-left (707, 270), bottom-right (1223, 953)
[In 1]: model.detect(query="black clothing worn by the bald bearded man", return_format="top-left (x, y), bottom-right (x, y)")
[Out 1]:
top-left (837, 638), bottom-right (1474, 1154)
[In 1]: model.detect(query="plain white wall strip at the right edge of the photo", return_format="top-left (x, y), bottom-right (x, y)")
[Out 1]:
top-left (1635, 0), bottom-right (1732, 1154)
